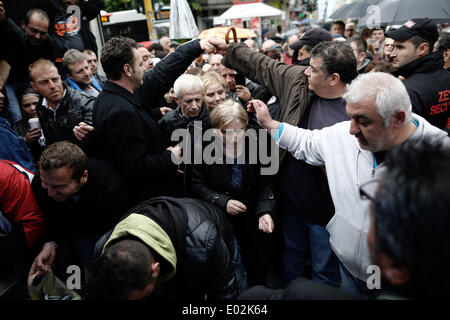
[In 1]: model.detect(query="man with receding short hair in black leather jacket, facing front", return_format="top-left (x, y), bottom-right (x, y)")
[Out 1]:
top-left (30, 59), bottom-right (95, 147)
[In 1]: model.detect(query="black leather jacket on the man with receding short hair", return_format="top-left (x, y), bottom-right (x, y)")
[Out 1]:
top-left (36, 85), bottom-right (95, 148)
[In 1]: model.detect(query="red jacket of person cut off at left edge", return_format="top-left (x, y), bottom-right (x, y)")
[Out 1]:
top-left (0, 160), bottom-right (45, 252)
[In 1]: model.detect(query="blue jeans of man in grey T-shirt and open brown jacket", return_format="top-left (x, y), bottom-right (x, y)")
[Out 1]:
top-left (282, 207), bottom-right (340, 287)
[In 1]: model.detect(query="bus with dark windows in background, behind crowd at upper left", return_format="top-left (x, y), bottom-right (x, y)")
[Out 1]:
top-left (100, 6), bottom-right (170, 42)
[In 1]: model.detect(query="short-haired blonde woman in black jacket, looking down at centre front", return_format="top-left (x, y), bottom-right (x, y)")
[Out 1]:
top-left (192, 100), bottom-right (275, 286)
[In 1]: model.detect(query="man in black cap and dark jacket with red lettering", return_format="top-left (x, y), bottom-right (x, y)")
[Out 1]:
top-left (387, 19), bottom-right (450, 132)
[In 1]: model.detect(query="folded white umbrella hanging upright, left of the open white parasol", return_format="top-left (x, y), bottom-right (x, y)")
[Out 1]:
top-left (169, 0), bottom-right (198, 39)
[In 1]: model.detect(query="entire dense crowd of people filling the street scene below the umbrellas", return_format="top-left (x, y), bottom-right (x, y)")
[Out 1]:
top-left (0, 0), bottom-right (450, 300)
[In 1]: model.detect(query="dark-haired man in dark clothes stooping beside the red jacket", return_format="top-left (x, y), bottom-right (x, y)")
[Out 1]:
top-left (30, 141), bottom-right (130, 286)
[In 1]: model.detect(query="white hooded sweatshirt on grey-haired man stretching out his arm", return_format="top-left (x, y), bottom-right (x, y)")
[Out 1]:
top-left (277, 114), bottom-right (450, 281)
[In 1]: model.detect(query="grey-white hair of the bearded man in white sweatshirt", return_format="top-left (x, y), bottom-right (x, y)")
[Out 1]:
top-left (342, 72), bottom-right (412, 127)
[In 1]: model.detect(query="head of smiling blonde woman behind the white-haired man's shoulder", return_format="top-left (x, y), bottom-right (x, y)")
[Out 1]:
top-left (202, 71), bottom-right (226, 111)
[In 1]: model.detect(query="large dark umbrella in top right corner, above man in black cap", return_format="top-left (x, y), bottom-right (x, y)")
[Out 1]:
top-left (358, 0), bottom-right (450, 28)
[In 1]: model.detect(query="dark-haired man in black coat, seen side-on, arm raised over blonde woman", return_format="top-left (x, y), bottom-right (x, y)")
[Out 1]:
top-left (91, 37), bottom-right (216, 203)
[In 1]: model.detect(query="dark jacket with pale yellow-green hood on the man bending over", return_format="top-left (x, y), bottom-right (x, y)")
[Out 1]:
top-left (95, 197), bottom-right (238, 299)
